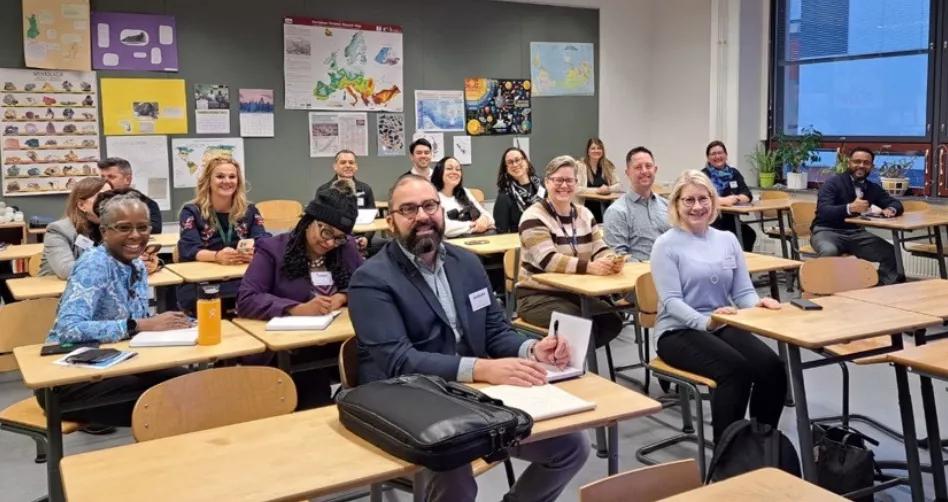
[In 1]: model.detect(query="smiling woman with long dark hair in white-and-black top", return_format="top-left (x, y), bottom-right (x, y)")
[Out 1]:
top-left (431, 157), bottom-right (494, 237)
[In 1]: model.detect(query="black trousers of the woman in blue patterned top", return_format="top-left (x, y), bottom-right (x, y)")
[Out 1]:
top-left (35, 368), bottom-right (188, 427)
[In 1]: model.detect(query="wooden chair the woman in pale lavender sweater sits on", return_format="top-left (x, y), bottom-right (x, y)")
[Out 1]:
top-left (635, 273), bottom-right (717, 477)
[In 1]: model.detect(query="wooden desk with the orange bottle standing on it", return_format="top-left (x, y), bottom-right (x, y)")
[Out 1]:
top-left (13, 321), bottom-right (266, 502)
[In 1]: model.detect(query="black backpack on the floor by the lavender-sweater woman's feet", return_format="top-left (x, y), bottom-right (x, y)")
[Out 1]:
top-left (705, 419), bottom-right (800, 483)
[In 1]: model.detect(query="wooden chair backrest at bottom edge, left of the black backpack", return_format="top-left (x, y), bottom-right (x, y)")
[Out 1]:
top-left (579, 458), bottom-right (701, 502)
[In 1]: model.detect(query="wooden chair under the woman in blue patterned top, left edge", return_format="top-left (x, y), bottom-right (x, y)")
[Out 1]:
top-left (0, 298), bottom-right (79, 463)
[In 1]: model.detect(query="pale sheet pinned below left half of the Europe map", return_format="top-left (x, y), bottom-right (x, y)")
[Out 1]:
top-left (309, 112), bottom-right (369, 157)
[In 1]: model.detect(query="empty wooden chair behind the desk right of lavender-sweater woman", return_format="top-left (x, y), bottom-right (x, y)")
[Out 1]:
top-left (800, 256), bottom-right (902, 439)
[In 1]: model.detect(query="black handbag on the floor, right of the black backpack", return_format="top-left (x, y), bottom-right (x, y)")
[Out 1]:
top-left (813, 424), bottom-right (879, 502)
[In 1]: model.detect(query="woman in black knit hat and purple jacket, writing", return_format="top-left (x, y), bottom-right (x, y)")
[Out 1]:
top-left (237, 180), bottom-right (362, 409)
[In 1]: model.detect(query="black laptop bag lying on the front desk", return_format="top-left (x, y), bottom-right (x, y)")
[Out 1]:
top-left (336, 375), bottom-right (533, 471)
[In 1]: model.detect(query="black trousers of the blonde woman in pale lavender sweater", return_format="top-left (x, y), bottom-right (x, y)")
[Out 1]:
top-left (658, 326), bottom-right (787, 441)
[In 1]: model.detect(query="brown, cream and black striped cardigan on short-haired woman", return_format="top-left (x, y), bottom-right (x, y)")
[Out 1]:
top-left (517, 200), bottom-right (612, 291)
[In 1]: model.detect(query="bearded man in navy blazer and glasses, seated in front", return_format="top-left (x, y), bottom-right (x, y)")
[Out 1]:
top-left (349, 175), bottom-right (589, 502)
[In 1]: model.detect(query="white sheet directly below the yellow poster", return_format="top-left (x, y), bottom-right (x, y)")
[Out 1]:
top-left (105, 136), bottom-right (171, 211)
